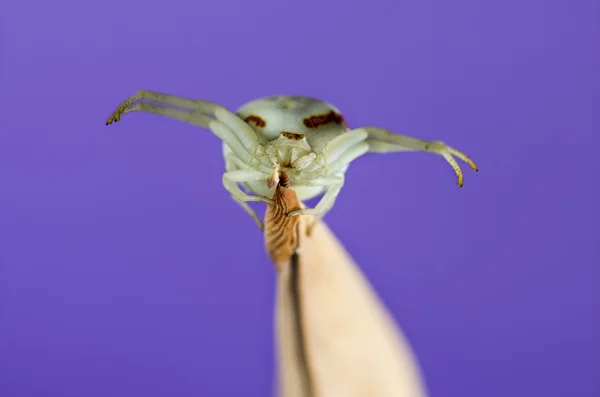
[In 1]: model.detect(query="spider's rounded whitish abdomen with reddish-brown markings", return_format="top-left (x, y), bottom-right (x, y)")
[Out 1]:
top-left (237, 95), bottom-right (348, 143)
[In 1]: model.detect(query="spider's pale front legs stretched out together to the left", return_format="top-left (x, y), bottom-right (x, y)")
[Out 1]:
top-left (106, 90), bottom-right (258, 156)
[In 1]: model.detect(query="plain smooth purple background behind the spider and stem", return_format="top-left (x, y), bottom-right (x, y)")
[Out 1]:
top-left (0, 0), bottom-right (600, 397)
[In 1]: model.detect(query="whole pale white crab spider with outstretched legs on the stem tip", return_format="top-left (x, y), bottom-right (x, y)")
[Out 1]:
top-left (106, 90), bottom-right (477, 229)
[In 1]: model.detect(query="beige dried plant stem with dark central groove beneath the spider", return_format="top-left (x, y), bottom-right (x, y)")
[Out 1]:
top-left (265, 177), bottom-right (426, 397)
